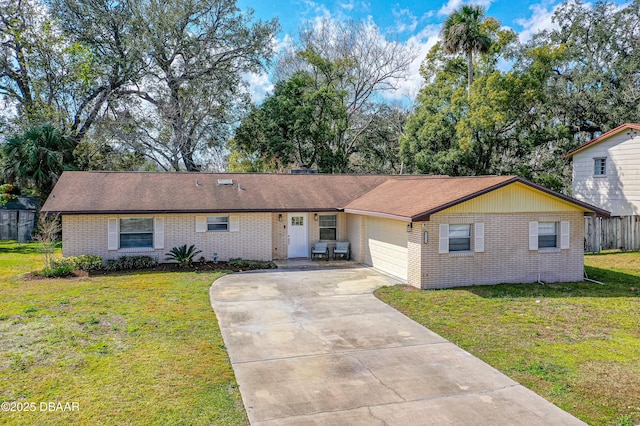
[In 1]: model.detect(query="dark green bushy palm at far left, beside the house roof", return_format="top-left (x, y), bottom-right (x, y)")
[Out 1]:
top-left (3, 124), bottom-right (75, 199)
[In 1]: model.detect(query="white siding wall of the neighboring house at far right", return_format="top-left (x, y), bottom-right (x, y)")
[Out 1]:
top-left (573, 130), bottom-right (640, 216)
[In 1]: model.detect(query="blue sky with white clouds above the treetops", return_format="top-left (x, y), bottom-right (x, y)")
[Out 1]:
top-left (238, 0), bottom-right (576, 102)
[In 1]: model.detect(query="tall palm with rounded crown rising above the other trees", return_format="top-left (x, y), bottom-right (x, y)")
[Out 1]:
top-left (440, 5), bottom-right (491, 95)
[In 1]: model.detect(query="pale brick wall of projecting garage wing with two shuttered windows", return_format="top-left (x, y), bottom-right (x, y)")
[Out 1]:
top-left (408, 212), bottom-right (584, 289)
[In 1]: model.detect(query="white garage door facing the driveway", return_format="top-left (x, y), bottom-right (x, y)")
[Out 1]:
top-left (364, 217), bottom-right (407, 280)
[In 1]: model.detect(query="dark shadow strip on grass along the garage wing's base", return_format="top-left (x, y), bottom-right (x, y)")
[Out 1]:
top-left (464, 267), bottom-right (640, 298)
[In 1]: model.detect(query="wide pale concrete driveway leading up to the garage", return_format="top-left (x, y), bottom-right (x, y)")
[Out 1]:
top-left (210, 267), bottom-right (584, 426)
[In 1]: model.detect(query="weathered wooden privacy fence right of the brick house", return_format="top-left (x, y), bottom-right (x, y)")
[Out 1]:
top-left (584, 216), bottom-right (640, 252)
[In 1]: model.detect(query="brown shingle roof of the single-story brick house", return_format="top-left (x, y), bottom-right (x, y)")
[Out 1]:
top-left (42, 172), bottom-right (608, 221)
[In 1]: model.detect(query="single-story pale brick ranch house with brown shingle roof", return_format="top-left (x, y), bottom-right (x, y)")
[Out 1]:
top-left (43, 172), bottom-right (608, 288)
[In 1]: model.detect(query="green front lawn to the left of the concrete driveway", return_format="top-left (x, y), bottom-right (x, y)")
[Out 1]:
top-left (0, 242), bottom-right (248, 425)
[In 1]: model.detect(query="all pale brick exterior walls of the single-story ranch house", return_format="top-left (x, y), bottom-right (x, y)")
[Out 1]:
top-left (62, 212), bottom-right (584, 289)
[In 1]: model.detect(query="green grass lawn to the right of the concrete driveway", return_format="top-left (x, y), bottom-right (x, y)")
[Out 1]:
top-left (376, 253), bottom-right (640, 425)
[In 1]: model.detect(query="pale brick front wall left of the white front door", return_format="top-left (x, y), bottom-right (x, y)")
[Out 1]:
top-left (62, 213), bottom-right (277, 262)
